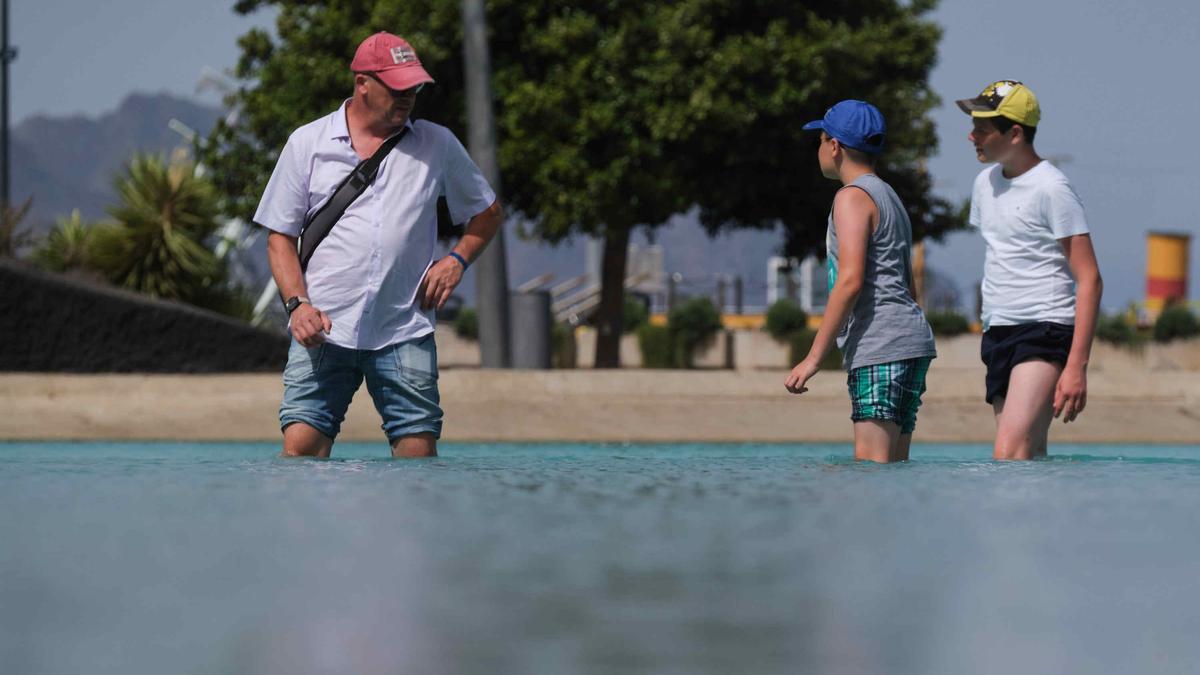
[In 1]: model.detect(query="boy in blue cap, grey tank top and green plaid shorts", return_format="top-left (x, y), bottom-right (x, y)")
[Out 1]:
top-left (785, 101), bottom-right (937, 462)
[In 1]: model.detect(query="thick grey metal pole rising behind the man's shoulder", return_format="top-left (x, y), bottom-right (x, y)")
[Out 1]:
top-left (462, 0), bottom-right (512, 368)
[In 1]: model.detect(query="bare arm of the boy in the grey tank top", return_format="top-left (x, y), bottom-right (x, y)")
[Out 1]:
top-left (784, 189), bottom-right (875, 394)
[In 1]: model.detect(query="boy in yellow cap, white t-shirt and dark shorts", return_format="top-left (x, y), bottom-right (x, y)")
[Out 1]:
top-left (958, 79), bottom-right (1103, 459)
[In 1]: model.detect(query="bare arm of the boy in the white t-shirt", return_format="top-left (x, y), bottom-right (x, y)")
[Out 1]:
top-left (1054, 234), bottom-right (1104, 422)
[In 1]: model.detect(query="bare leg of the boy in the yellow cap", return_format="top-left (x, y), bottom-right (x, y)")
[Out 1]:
top-left (992, 360), bottom-right (1062, 459)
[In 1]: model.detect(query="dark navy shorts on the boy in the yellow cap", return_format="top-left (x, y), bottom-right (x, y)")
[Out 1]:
top-left (979, 321), bottom-right (1075, 404)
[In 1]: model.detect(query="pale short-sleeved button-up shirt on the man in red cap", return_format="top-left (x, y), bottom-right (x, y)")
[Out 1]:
top-left (254, 103), bottom-right (496, 350)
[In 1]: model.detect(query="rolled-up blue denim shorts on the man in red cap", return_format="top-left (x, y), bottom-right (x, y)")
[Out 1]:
top-left (280, 333), bottom-right (442, 442)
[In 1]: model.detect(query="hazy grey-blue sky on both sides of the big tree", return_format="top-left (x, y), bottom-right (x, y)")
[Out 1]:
top-left (10, 0), bottom-right (1200, 307)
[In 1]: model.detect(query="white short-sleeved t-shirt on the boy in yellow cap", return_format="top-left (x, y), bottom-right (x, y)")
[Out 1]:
top-left (971, 161), bottom-right (1088, 330)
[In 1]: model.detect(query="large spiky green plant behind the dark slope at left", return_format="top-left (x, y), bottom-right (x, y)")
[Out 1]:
top-left (91, 153), bottom-right (224, 301)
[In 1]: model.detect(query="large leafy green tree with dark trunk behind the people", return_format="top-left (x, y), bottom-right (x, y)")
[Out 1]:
top-left (204, 0), bottom-right (960, 366)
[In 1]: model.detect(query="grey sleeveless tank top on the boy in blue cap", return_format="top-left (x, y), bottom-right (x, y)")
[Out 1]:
top-left (826, 174), bottom-right (937, 371)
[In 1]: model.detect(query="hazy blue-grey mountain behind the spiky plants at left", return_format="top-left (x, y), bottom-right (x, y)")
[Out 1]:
top-left (10, 94), bottom-right (221, 233)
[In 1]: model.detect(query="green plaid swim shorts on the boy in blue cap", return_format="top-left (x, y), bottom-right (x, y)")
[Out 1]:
top-left (846, 357), bottom-right (934, 434)
